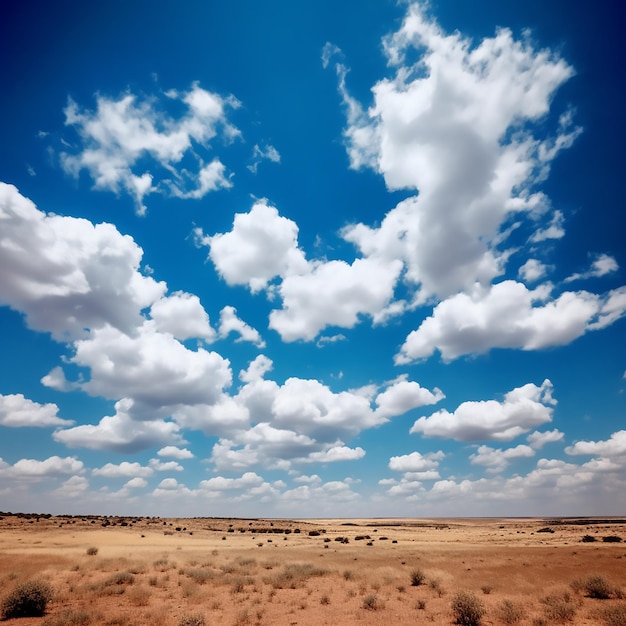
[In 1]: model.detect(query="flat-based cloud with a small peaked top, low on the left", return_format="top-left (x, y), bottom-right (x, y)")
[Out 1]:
top-left (52, 399), bottom-right (182, 453)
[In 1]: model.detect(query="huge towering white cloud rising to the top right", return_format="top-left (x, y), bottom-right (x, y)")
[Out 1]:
top-left (332, 3), bottom-right (580, 302)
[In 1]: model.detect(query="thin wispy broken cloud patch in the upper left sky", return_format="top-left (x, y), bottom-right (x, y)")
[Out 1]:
top-left (61, 83), bottom-right (239, 215)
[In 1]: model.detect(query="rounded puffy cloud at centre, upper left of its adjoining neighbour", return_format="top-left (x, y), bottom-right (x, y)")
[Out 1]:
top-left (201, 200), bottom-right (307, 292)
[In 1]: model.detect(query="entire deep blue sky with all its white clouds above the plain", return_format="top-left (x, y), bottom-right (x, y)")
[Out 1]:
top-left (0, 0), bottom-right (626, 517)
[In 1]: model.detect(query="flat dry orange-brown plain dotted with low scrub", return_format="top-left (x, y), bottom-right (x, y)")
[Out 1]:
top-left (0, 514), bottom-right (626, 626)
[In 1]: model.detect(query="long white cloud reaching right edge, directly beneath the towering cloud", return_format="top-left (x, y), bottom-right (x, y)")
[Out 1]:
top-left (396, 280), bottom-right (626, 364)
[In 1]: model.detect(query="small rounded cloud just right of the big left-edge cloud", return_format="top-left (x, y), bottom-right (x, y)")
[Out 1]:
top-left (150, 291), bottom-right (215, 341)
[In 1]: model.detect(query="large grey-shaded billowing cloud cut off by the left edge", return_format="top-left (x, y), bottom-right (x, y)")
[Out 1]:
top-left (0, 183), bottom-right (166, 341)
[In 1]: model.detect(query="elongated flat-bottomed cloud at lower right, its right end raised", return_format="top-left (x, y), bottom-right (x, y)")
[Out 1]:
top-left (410, 380), bottom-right (556, 441)
